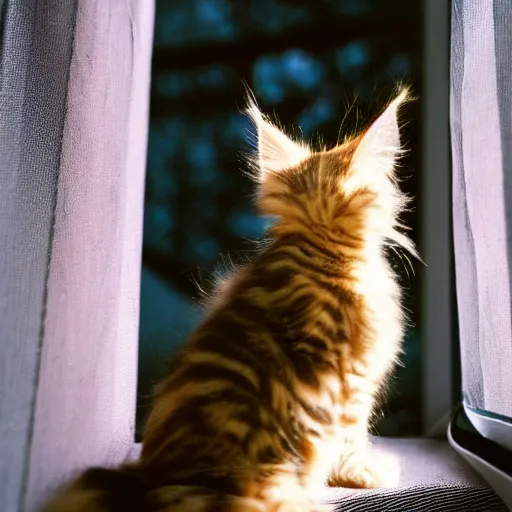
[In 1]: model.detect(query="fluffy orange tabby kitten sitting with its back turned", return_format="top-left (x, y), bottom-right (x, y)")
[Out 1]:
top-left (45, 90), bottom-right (416, 512)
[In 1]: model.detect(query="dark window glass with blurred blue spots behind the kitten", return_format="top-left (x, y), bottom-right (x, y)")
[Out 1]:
top-left (137, 0), bottom-right (422, 435)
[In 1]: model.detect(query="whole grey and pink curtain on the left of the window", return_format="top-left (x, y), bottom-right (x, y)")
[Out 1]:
top-left (0, 0), bottom-right (154, 512)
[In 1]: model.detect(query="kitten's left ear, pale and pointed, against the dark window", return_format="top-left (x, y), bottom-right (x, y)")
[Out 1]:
top-left (246, 99), bottom-right (311, 181)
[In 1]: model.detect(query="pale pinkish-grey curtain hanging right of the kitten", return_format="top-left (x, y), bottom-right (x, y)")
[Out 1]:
top-left (451, 0), bottom-right (512, 418)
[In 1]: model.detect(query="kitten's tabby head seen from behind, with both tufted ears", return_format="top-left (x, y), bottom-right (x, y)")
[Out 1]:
top-left (247, 89), bottom-right (415, 253)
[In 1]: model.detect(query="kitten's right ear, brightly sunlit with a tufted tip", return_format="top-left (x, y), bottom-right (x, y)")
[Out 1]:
top-left (350, 89), bottom-right (409, 185)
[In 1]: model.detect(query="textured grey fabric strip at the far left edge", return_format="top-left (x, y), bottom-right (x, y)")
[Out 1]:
top-left (0, 0), bottom-right (75, 512)
